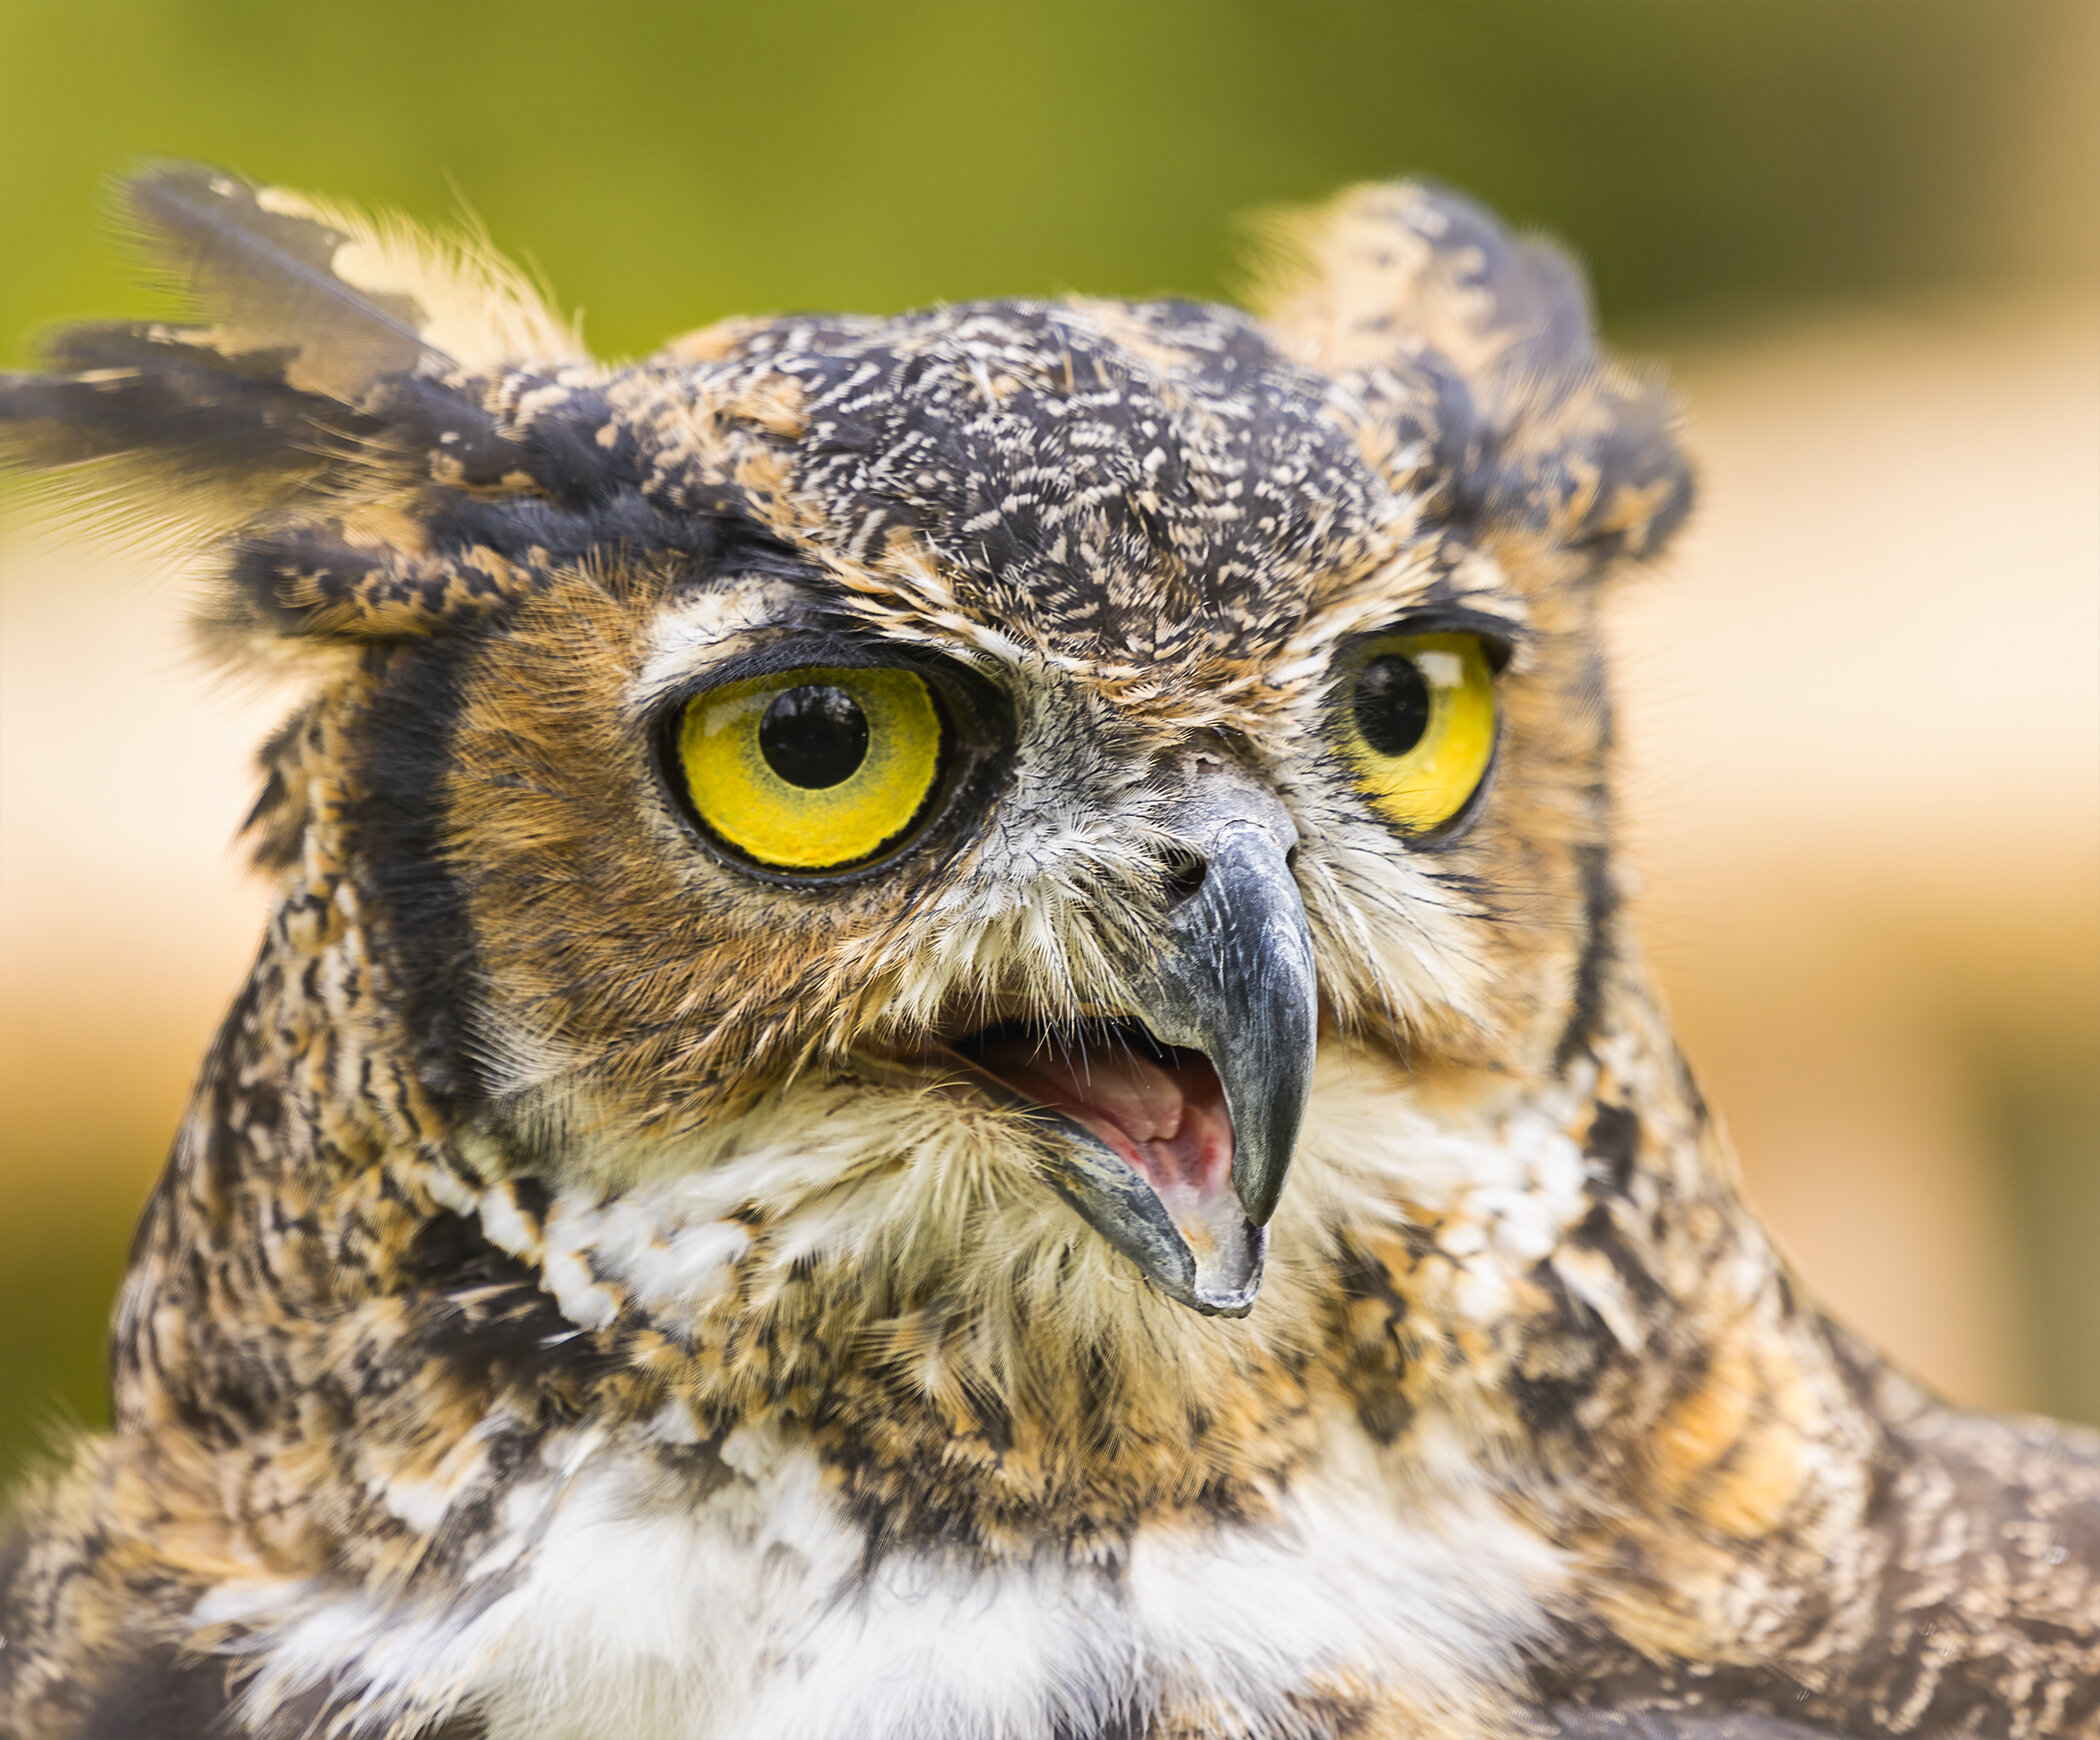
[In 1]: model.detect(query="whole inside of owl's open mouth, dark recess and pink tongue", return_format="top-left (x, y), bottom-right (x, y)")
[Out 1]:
top-left (956, 1020), bottom-right (1239, 1264)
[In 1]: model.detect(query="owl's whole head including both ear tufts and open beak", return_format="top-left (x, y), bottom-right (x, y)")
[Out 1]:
top-left (0, 166), bottom-right (1691, 1316)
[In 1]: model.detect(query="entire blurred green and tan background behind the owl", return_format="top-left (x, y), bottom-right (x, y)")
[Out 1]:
top-left (0, 0), bottom-right (2100, 1478)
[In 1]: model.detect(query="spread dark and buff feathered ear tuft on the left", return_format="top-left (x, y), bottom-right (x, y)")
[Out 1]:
top-left (0, 164), bottom-right (613, 644)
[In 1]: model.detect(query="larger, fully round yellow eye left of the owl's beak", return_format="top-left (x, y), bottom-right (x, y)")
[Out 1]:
top-left (678, 670), bottom-right (945, 871)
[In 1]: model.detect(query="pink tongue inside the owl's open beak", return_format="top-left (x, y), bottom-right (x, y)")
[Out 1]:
top-left (979, 1039), bottom-right (1233, 1192)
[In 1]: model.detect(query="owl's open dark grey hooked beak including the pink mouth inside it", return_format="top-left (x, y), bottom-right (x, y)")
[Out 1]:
top-left (964, 766), bottom-right (1319, 1316)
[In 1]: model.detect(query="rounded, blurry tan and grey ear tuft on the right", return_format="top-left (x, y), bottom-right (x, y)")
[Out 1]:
top-left (1254, 183), bottom-right (1693, 563)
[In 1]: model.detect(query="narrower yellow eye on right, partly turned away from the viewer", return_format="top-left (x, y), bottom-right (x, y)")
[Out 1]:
top-left (1336, 634), bottom-right (1495, 833)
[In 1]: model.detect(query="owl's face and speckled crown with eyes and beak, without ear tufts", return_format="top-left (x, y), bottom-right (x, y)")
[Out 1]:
top-left (394, 306), bottom-right (1629, 1312)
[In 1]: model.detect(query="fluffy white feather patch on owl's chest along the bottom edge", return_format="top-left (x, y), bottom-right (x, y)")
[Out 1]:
top-left (221, 1421), bottom-right (1562, 1740)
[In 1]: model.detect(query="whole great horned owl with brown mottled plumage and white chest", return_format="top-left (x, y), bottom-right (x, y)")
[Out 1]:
top-left (0, 168), bottom-right (2100, 1740)
